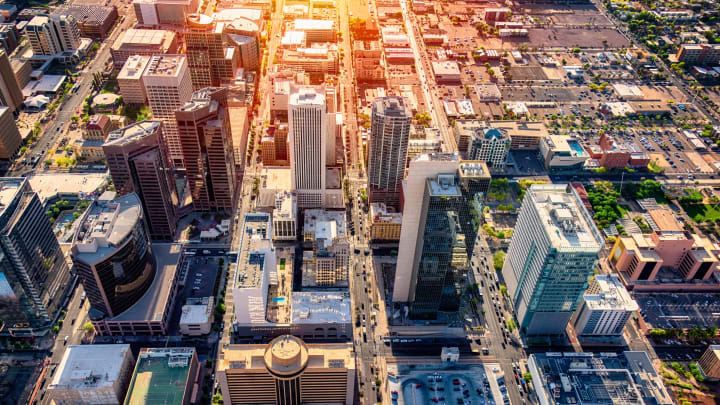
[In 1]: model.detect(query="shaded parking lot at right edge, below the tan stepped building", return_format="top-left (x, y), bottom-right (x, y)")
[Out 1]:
top-left (634, 293), bottom-right (720, 329)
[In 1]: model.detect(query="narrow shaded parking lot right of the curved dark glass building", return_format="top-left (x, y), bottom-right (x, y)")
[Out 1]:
top-left (169, 256), bottom-right (221, 335)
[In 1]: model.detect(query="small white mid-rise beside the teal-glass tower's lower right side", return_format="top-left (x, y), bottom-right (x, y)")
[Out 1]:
top-left (573, 274), bottom-right (639, 337)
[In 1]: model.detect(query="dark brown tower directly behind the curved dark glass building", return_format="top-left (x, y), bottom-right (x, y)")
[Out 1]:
top-left (103, 121), bottom-right (178, 239)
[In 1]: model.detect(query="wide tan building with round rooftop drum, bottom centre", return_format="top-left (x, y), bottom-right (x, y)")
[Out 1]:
top-left (217, 335), bottom-right (355, 405)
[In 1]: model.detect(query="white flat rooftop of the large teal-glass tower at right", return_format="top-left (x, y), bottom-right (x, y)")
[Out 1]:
top-left (523, 184), bottom-right (604, 252)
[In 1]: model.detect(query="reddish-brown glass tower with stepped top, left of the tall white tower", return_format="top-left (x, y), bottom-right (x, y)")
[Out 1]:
top-left (175, 87), bottom-right (237, 211)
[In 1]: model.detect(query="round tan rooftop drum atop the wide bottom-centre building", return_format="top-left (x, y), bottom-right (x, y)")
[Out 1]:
top-left (265, 335), bottom-right (308, 378)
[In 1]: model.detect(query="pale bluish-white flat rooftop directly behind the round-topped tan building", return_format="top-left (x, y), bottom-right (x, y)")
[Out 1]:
top-left (291, 292), bottom-right (352, 324)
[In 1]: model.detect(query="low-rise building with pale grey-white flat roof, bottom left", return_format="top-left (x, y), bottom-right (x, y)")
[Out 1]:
top-left (46, 344), bottom-right (135, 405)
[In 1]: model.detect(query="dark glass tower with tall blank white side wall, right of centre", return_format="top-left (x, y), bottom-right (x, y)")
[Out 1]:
top-left (393, 154), bottom-right (490, 319)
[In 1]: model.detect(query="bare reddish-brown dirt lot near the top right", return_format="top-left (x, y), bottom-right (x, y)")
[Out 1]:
top-left (527, 28), bottom-right (630, 48)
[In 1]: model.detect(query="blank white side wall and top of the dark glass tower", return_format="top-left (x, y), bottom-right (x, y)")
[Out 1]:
top-left (393, 153), bottom-right (460, 302)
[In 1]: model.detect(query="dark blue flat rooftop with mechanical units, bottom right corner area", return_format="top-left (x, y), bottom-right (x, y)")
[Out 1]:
top-left (528, 351), bottom-right (672, 405)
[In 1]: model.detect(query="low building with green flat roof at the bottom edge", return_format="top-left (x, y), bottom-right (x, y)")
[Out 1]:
top-left (125, 347), bottom-right (195, 405)
